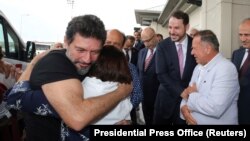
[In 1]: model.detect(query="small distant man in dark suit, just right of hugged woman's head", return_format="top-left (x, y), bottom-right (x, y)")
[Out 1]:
top-left (122, 35), bottom-right (138, 66)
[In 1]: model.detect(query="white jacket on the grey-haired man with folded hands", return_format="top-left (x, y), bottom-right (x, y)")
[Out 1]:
top-left (181, 54), bottom-right (240, 125)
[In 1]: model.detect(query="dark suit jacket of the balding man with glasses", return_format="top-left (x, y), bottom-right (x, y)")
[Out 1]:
top-left (137, 48), bottom-right (159, 124)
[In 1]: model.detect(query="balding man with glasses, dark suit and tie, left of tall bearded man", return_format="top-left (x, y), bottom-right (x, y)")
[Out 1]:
top-left (137, 27), bottom-right (159, 125)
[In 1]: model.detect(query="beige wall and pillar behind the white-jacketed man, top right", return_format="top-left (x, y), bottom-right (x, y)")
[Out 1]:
top-left (200, 0), bottom-right (250, 58)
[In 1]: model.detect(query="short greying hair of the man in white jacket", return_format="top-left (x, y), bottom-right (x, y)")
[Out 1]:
top-left (194, 30), bottom-right (220, 51)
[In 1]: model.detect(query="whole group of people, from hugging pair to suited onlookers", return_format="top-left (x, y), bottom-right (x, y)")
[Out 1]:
top-left (0, 11), bottom-right (250, 141)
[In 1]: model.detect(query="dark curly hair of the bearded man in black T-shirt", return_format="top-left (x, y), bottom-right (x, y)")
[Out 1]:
top-left (66, 15), bottom-right (106, 45)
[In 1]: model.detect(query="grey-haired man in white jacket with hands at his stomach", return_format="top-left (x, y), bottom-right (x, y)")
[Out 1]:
top-left (180, 30), bottom-right (239, 125)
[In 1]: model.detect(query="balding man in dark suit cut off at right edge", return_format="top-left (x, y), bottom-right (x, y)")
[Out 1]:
top-left (232, 18), bottom-right (250, 124)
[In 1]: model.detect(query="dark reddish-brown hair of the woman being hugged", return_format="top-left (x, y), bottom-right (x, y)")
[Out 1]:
top-left (89, 45), bottom-right (132, 83)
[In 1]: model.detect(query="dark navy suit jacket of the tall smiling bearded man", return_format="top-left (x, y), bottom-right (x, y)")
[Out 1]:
top-left (155, 36), bottom-right (196, 119)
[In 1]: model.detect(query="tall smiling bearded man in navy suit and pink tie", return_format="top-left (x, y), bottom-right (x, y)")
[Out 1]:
top-left (154, 11), bottom-right (196, 125)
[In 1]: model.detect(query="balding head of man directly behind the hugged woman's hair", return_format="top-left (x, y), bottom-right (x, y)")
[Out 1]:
top-left (105, 29), bottom-right (125, 49)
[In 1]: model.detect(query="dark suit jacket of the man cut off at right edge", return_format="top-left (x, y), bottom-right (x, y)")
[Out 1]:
top-left (232, 47), bottom-right (250, 124)
